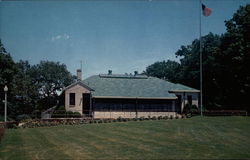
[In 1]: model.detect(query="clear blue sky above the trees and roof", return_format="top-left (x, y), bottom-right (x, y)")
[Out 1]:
top-left (0, 0), bottom-right (250, 79)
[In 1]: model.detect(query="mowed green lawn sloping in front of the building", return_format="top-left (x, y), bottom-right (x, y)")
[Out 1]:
top-left (0, 117), bottom-right (250, 159)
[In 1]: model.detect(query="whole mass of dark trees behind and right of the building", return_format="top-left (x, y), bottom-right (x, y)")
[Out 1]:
top-left (145, 4), bottom-right (250, 111)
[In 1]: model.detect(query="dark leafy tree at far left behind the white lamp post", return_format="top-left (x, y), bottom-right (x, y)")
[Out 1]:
top-left (0, 41), bottom-right (38, 119)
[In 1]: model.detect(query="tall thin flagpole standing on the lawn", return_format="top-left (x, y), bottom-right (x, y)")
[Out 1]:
top-left (199, 0), bottom-right (203, 116)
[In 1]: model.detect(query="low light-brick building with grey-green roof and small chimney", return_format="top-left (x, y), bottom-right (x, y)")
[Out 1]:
top-left (63, 70), bottom-right (199, 118)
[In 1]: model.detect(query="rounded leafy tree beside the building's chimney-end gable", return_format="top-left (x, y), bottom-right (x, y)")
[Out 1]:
top-left (31, 61), bottom-right (74, 110)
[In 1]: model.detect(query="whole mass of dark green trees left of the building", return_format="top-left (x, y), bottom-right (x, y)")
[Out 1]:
top-left (0, 41), bottom-right (76, 119)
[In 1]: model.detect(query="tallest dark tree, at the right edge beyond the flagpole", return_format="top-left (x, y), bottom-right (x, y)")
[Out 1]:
top-left (216, 4), bottom-right (250, 110)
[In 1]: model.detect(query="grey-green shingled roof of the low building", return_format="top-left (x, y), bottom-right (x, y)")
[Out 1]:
top-left (83, 74), bottom-right (197, 98)
